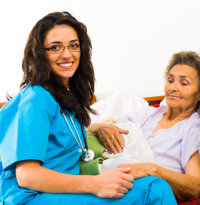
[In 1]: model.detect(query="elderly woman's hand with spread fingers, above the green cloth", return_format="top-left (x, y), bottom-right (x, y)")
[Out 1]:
top-left (88, 120), bottom-right (129, 154)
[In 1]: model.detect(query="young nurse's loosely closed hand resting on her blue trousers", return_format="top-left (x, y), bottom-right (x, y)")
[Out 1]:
top-left (92, 168), bottom-right (134, 198)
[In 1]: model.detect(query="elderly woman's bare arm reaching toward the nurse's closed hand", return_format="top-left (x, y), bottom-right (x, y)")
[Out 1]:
top-left (119, 151), bottom-right (200, 200)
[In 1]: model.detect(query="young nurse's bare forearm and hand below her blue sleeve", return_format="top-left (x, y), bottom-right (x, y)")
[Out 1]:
top-left (16, 160), bottom-right (133, 198)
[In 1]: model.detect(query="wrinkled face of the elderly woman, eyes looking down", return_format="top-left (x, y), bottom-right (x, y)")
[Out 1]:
top-left (165, 64), bottom-right (200, 112)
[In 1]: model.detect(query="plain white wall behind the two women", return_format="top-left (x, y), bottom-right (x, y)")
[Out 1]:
top-left (0, 0), bottom-right (200, 102)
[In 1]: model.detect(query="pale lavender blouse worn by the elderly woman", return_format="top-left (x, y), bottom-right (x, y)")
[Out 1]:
top-left (115, 105), bottom-right (200, 173)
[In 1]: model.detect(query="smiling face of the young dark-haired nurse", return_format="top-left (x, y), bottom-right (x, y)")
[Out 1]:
top-left (44, 24), bottom-right (81, 85)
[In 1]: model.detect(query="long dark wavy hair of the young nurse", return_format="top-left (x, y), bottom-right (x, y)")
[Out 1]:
top-left (20, 11), bottom-right (95, 126)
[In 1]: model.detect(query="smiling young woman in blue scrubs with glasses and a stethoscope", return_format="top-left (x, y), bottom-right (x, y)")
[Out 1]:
top-left (0, 12), bottom-right (176, 205)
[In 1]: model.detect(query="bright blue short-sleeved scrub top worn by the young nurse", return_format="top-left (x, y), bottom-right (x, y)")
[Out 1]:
top-left (0, 85), bottom-right (85, 204)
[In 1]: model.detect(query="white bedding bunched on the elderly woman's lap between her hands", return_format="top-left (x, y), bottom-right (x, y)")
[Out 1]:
top-left (101, 121), bottom-right (154, 171)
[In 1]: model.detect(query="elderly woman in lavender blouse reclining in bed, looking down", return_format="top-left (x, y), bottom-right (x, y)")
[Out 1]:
top-left (88, 52), bottom-right (200, 200)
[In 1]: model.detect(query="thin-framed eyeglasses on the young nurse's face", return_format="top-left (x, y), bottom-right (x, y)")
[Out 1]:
top-left (44, 43), bottom-right (81, 54)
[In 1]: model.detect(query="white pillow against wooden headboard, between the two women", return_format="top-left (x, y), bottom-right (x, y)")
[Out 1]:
top-left (90, 90), bottom-right (148, 123)
